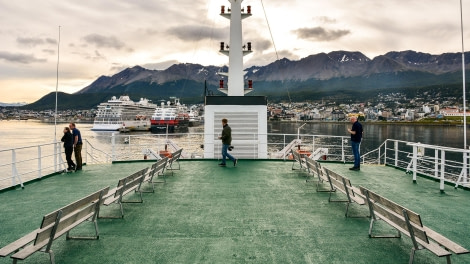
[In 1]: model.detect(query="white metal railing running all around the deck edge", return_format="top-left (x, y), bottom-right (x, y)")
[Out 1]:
top-left (0, 133), bottom-right (470, 190)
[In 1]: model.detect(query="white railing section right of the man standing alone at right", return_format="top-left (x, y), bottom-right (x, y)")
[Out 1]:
top-left (362, 139), bottom-right (470, 191)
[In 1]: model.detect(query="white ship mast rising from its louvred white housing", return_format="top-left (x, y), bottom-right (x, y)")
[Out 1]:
top-left (204, 0), bottom-right (268, 159)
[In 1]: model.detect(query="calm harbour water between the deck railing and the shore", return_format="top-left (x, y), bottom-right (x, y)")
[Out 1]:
top-left (0, 120), bottom-right (470, 152)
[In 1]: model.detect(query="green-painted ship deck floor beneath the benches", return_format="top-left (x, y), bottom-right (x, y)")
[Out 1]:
top-left (0, 160), bottom-right (470, 264)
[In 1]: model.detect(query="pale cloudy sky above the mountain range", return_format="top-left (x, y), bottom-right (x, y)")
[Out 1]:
top-left (0, 0), bottom-right (470, 103)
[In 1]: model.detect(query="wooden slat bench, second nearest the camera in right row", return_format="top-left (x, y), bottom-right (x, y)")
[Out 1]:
top-left (323, 168), bottom-right (365, 217)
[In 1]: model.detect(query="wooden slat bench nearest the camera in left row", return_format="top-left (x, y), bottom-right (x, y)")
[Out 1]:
top-left (0, 187), bottom-right (109, 263)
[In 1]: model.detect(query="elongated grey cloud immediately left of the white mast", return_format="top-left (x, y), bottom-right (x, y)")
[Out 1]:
top-left (167, 26), bottom-right (229, 41)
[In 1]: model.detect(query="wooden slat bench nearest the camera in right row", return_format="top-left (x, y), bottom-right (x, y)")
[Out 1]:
top-left (359, 186), bottom-right (469, 263)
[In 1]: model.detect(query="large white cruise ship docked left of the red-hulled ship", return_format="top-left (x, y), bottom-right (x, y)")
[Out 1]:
top-left (92, 95), bottom-right (157, 131)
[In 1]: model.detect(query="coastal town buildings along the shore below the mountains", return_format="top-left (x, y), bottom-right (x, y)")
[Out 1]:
top-left (0, 92), bottom-right (470, 123)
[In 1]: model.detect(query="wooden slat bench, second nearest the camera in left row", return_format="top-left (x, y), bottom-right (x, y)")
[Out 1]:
top-left (99, 168), bottom-right (149, 218)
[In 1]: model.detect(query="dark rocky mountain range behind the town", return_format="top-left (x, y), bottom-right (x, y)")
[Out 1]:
top-left (23, 50), bottom-right (470, 108)
